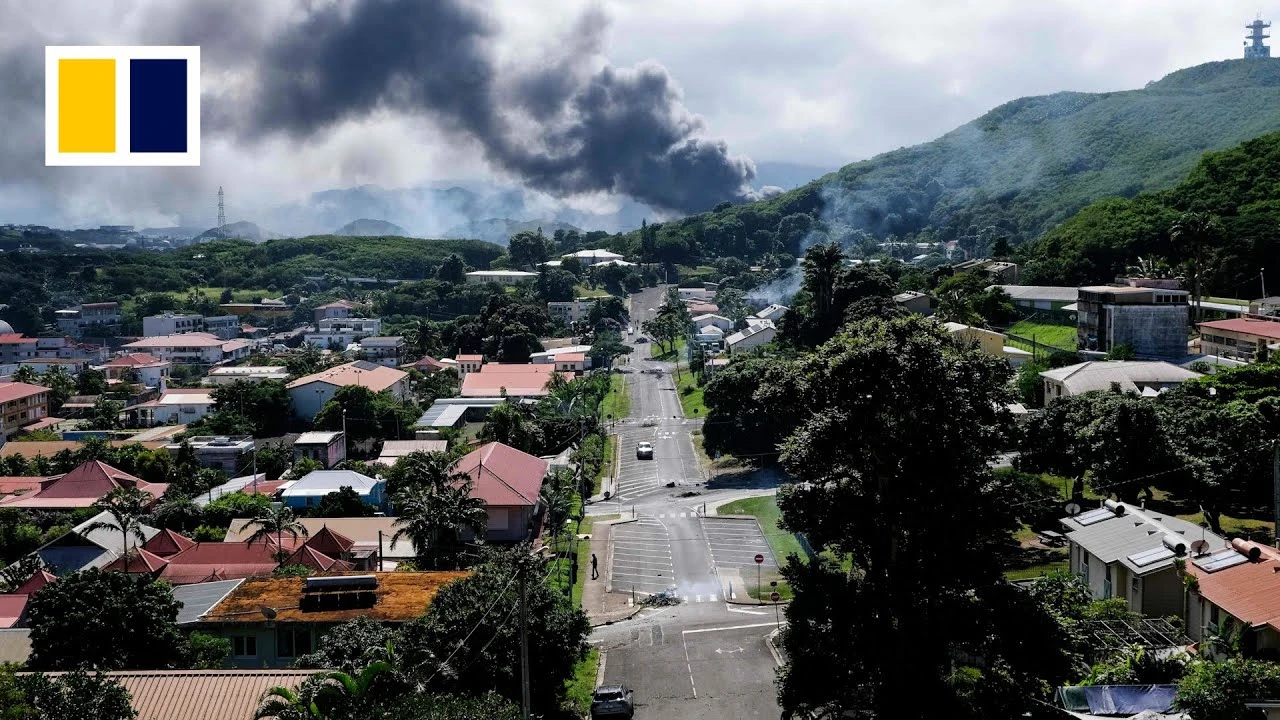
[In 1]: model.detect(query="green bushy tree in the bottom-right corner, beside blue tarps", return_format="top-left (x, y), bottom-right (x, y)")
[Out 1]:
top-left (1175, 657), bottom-right (1280, 720)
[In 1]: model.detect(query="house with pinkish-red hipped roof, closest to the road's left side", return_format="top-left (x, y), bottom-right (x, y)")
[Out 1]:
top-left (453, 442), bottom-right (550, 542)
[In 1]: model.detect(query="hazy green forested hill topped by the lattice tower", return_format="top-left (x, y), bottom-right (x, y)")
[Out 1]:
top-left (620, 59), bottom-right (1280, 260)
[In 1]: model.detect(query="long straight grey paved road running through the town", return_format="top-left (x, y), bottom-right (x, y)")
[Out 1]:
top-left (590, 288), bottom-right (780, 720)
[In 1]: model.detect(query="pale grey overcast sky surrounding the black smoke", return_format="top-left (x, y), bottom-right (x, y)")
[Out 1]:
top-left (0, 0), bottom-right (1280, 224)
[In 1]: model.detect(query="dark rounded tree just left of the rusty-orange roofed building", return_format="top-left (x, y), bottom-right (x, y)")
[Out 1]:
top-left (27, 569), bottom-right (186, 670)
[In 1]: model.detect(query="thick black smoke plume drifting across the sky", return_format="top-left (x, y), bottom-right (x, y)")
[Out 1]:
top-left (216, 0), bottom-right (756, 213)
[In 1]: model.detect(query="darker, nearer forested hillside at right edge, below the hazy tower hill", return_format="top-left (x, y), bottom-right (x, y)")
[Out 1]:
top-left (1021, 126), bottom-right (1280, 292)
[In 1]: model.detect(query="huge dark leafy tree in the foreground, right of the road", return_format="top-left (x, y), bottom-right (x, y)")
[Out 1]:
top-left (778, 316), bottom-right (1069, 719)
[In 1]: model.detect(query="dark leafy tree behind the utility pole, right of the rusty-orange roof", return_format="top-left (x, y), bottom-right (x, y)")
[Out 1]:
top-left (397, 547), bottom-right (590, 714)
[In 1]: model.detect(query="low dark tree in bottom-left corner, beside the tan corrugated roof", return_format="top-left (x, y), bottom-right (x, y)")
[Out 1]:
top-left (18, 669), bottom-right (138, 720)
